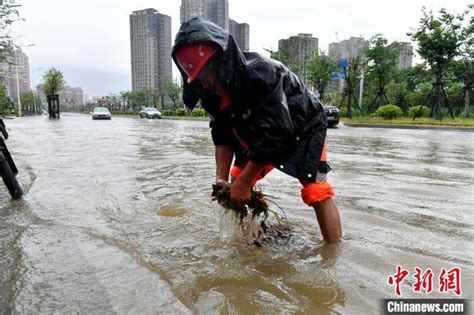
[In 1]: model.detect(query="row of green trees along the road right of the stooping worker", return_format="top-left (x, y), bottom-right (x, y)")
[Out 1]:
top-left (270, 5), bottom-right (474, 119)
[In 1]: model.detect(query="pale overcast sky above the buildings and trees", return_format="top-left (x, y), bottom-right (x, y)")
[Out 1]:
top-left (14, 0), bottom-right (474, 96)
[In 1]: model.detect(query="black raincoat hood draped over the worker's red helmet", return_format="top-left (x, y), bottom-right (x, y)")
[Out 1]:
top-left (171, 18), bottom-right (244, 109)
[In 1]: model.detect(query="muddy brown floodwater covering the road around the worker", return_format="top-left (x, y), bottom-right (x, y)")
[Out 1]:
top-left (0, 114), bottom-right (474, 314)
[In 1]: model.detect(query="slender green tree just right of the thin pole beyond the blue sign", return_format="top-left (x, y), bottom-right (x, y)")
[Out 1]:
top-left (365, 34), bottom-right (398, 110)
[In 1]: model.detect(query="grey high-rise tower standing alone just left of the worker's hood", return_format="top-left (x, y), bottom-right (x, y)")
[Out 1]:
top-left (130, 9), bottom-right (172, 93)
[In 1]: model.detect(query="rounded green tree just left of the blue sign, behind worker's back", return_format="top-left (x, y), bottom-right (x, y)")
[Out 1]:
top-left (307, 50), bottom-right (339, 100)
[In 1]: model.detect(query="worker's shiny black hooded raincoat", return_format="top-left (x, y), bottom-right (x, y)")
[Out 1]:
top-left (172, 18), bottom-right (330, 182)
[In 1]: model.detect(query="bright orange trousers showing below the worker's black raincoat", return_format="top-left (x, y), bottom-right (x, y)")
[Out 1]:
top-left (230, 142), bottom-right (334, 206)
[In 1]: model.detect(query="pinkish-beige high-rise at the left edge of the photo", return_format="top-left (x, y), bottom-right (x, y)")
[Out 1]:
top-left (0, 49), bottom-right (30, 101)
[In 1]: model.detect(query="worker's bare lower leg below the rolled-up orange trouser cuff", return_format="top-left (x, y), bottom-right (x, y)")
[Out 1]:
top-left (313, 198), bottom-right (342, 244)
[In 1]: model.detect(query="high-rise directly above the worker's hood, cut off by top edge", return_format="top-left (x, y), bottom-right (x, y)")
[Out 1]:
top-left (180, 0), bottom-right (229, 30)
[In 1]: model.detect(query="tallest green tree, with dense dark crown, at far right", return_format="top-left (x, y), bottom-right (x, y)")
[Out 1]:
top-left (407, 8), bottom-right (466, 120)
